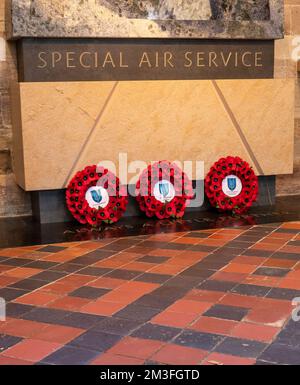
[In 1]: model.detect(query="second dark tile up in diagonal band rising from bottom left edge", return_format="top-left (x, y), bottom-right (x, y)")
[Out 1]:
top-left (68, 330), bottom-right (122, 352)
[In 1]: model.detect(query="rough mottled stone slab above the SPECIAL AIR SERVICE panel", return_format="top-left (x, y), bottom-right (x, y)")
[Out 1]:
top-left (8, 0), bottom-right (284, 39)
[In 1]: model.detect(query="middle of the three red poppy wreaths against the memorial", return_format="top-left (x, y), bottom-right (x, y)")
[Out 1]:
top-left (136, 161), bottom-right (193, 219)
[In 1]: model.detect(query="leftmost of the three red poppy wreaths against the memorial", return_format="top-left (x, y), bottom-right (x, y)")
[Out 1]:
top-left (66, 165), bottom-right (128, 226)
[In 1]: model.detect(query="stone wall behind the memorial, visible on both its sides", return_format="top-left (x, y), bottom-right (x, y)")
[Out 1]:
top-left (0, 0), bottom-right (300, 217)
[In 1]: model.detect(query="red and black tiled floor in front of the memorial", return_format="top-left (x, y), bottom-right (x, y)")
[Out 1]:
top-left (0, 222), bottom-right (300, 365)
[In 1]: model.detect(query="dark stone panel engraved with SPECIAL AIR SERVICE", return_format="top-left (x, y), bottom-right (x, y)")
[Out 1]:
top-left (18, 39), bottom-right (274, 82)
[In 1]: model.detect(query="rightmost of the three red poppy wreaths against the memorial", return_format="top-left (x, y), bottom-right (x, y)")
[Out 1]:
top-left (205, 156), bottom-right (258, 214)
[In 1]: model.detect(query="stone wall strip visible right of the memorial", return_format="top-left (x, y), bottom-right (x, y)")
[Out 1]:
top-left (277, 0), bottom-right (300, 195)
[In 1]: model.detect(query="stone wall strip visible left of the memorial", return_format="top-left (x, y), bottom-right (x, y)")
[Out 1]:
top-left (0, 0), bottom-right (31, 217)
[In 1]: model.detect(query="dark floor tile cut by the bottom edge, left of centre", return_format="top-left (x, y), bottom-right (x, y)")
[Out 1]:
top-left (41, 346), bottom-right (99, 365)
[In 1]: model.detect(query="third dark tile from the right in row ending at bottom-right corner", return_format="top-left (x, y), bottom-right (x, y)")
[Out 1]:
top-left (174, 330), bottom-right (224, 350)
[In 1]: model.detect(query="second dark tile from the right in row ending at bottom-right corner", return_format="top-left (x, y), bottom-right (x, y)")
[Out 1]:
top-left (215, 337), bottom-right (267, 358)
